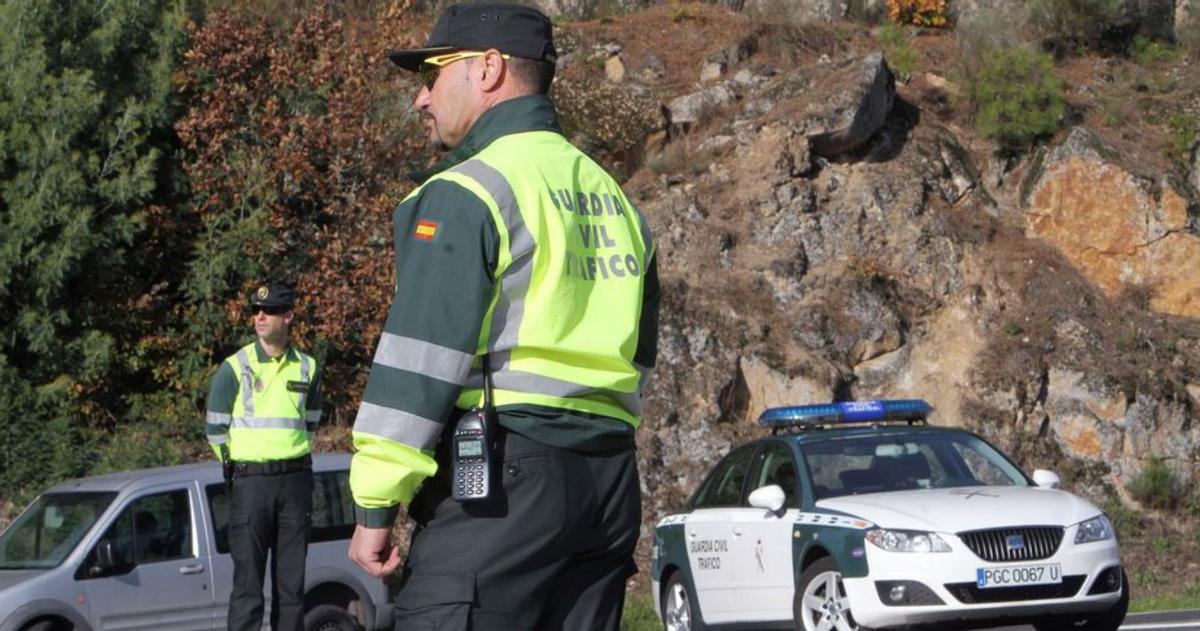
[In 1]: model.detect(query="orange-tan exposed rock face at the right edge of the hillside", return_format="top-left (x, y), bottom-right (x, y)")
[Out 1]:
top-left (1025, 128), bottom-right (1200, 318)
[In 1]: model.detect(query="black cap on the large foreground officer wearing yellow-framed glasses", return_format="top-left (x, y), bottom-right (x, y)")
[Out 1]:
top-left (388, 2), bottom-right (558, 72)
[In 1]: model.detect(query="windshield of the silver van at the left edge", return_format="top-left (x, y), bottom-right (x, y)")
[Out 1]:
top-left (0, 493), bottom-right (116, 570)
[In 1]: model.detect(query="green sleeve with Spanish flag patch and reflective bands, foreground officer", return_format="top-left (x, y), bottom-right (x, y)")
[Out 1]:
top-left (350, 180), bottom-right (499, 528)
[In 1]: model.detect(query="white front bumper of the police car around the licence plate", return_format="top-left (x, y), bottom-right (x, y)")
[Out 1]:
top-left (842, 531), bottom-right (1127, 627)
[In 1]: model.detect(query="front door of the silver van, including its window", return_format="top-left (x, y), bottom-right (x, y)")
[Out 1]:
top-left (77, 485), bottom-right (214, 631)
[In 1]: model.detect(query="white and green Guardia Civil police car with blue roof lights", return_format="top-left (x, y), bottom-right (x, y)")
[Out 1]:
top-left (652, 401), bottom-right (1129, 631)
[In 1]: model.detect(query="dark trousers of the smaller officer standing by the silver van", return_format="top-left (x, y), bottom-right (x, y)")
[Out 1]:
top-left (228, 470), bottom-right (312, 631)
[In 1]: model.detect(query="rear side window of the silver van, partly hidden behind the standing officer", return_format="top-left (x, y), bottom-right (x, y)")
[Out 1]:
top-left (205, 469), bottom-right (355, 554)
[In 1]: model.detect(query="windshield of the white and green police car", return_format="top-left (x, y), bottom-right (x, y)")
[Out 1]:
top-left (802, 432), bottom-right (1030, 500)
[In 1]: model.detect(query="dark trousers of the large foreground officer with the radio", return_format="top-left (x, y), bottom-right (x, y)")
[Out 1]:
top-left (395, 432), bottom-right (642, 631)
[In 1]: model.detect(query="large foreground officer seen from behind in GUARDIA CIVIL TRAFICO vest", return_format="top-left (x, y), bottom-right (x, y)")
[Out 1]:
top-left (350, 4), bottom-right (659, 630)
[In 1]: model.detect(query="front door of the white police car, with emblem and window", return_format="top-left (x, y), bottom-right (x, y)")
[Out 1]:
top-left (733, 443), bottom-right (800, 621)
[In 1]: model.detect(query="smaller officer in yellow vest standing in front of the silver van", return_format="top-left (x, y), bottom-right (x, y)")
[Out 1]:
top-left (206, 282), bottom-right (322, 631)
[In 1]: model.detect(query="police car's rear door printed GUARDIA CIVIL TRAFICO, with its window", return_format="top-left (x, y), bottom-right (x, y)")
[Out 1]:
top-left (684, 445), bottom-right (757, 624)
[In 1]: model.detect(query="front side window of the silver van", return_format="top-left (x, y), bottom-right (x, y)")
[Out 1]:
top-left (84, 488), bottom-right (196, 575)
